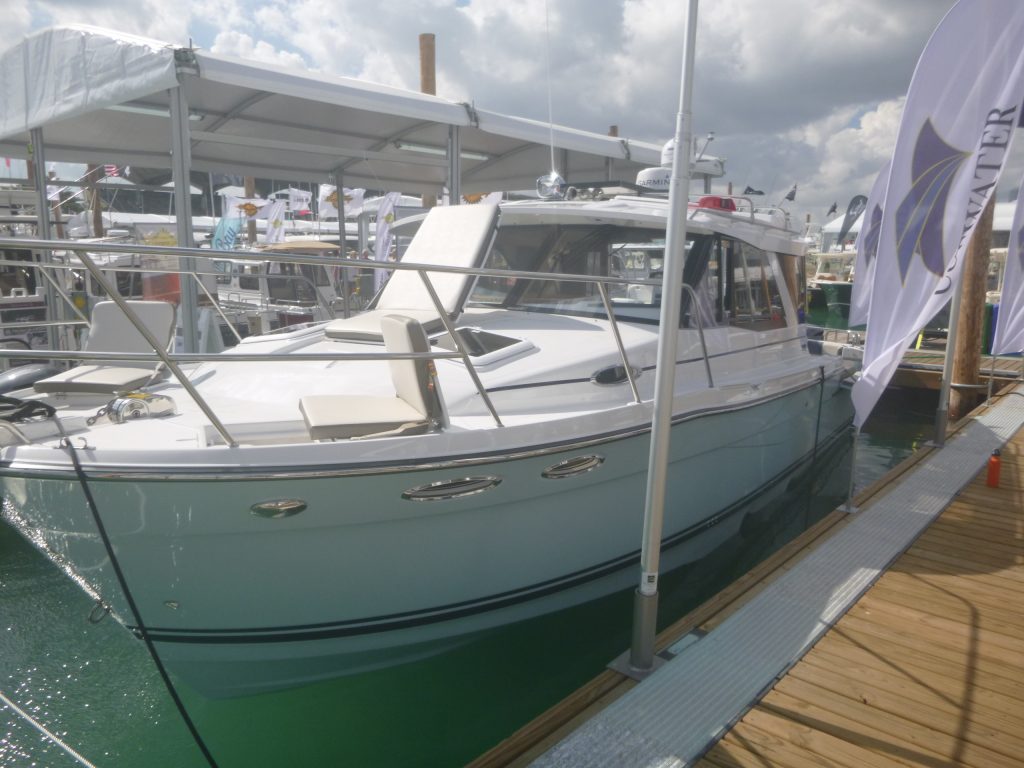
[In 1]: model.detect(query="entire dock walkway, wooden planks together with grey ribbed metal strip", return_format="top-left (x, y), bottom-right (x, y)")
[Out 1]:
top-left (470, 385), bottom-right (1024, 768)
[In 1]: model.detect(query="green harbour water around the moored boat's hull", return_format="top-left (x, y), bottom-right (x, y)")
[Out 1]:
top-left (0, 393), bottom-right (935, 768)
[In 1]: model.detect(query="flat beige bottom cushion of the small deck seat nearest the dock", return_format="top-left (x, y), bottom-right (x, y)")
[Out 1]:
top-left (299, 394), bottom-right (427, 440)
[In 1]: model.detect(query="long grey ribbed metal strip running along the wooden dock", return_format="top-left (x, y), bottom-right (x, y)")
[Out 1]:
top-left (531, 387), bottom-right (1024, 768)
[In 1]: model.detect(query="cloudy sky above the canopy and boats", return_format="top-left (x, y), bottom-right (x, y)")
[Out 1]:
top-left (0, 0), bottom-right (1024, 223)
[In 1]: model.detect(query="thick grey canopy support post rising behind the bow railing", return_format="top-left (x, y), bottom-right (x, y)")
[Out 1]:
top-left (170, 81), bottom-right (199, 352)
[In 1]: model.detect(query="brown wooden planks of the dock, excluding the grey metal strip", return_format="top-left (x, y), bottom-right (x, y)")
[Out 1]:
top-left (471, 393), bottom-right (1024, 768)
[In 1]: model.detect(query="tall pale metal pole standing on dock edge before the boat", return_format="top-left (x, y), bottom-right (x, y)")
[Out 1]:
top-left (630, 0), bottom-right (697, 673)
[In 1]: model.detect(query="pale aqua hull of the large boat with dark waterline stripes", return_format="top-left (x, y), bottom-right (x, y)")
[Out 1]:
top-left (3, 378), bottom-right (850, 696)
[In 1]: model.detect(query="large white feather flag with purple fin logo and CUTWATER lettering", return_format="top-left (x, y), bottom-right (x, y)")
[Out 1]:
top-left (853, 0), bottom-right (1024, 427)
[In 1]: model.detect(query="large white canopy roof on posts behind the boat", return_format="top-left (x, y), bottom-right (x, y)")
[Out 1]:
top-left (0, 27), bottom-right (721, 194)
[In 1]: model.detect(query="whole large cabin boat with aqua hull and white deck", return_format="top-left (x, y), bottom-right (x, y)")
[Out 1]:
top-left (0, 185), bottom-right (851, 696)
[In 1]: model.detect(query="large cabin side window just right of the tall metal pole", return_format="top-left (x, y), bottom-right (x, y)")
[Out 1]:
top-left (720, 238), bottom-right (786, 331)
